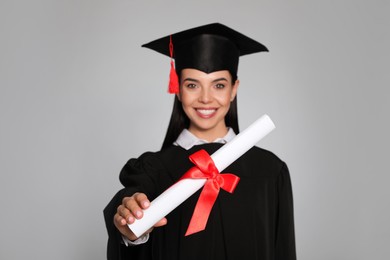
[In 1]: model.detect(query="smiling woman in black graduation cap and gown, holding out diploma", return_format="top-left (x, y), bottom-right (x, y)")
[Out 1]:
top-left (104, 24), bottom-right (296, 260)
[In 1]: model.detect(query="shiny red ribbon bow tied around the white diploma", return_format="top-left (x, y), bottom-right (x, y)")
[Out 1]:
top-left (181, 150), bottom-right (240, 236)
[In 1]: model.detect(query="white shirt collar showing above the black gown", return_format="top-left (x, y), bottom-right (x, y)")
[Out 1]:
top-left (173, 127), bottom-right (236, 150)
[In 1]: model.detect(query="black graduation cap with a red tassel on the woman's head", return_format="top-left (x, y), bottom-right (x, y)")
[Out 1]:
top-left (142, 23), bottom-right (268, 93)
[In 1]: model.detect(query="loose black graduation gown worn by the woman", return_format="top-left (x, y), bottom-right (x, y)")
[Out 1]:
top-left (104, 143), bottom-right (296, 260)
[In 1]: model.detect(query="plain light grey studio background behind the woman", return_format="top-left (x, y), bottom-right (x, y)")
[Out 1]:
top-left (0, 0), bottom-right (390, 260)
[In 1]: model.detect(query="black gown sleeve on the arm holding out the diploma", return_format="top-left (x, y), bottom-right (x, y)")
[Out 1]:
top-left (103, 152), bottom-right (162, 260)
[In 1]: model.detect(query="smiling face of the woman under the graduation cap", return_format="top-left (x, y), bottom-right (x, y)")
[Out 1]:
top-left (178, 69), bottom-right (239, 141)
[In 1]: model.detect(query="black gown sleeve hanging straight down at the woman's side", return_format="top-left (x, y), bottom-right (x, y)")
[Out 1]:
top-left (275, 164), bottom-right (296, 260)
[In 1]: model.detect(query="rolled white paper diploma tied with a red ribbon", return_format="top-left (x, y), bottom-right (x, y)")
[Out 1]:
top-left (128, 115), bottom-right (275, 237)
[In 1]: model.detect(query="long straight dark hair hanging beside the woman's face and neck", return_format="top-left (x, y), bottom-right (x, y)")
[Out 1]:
top-left (162, 73), bottom-right (240, 149)
